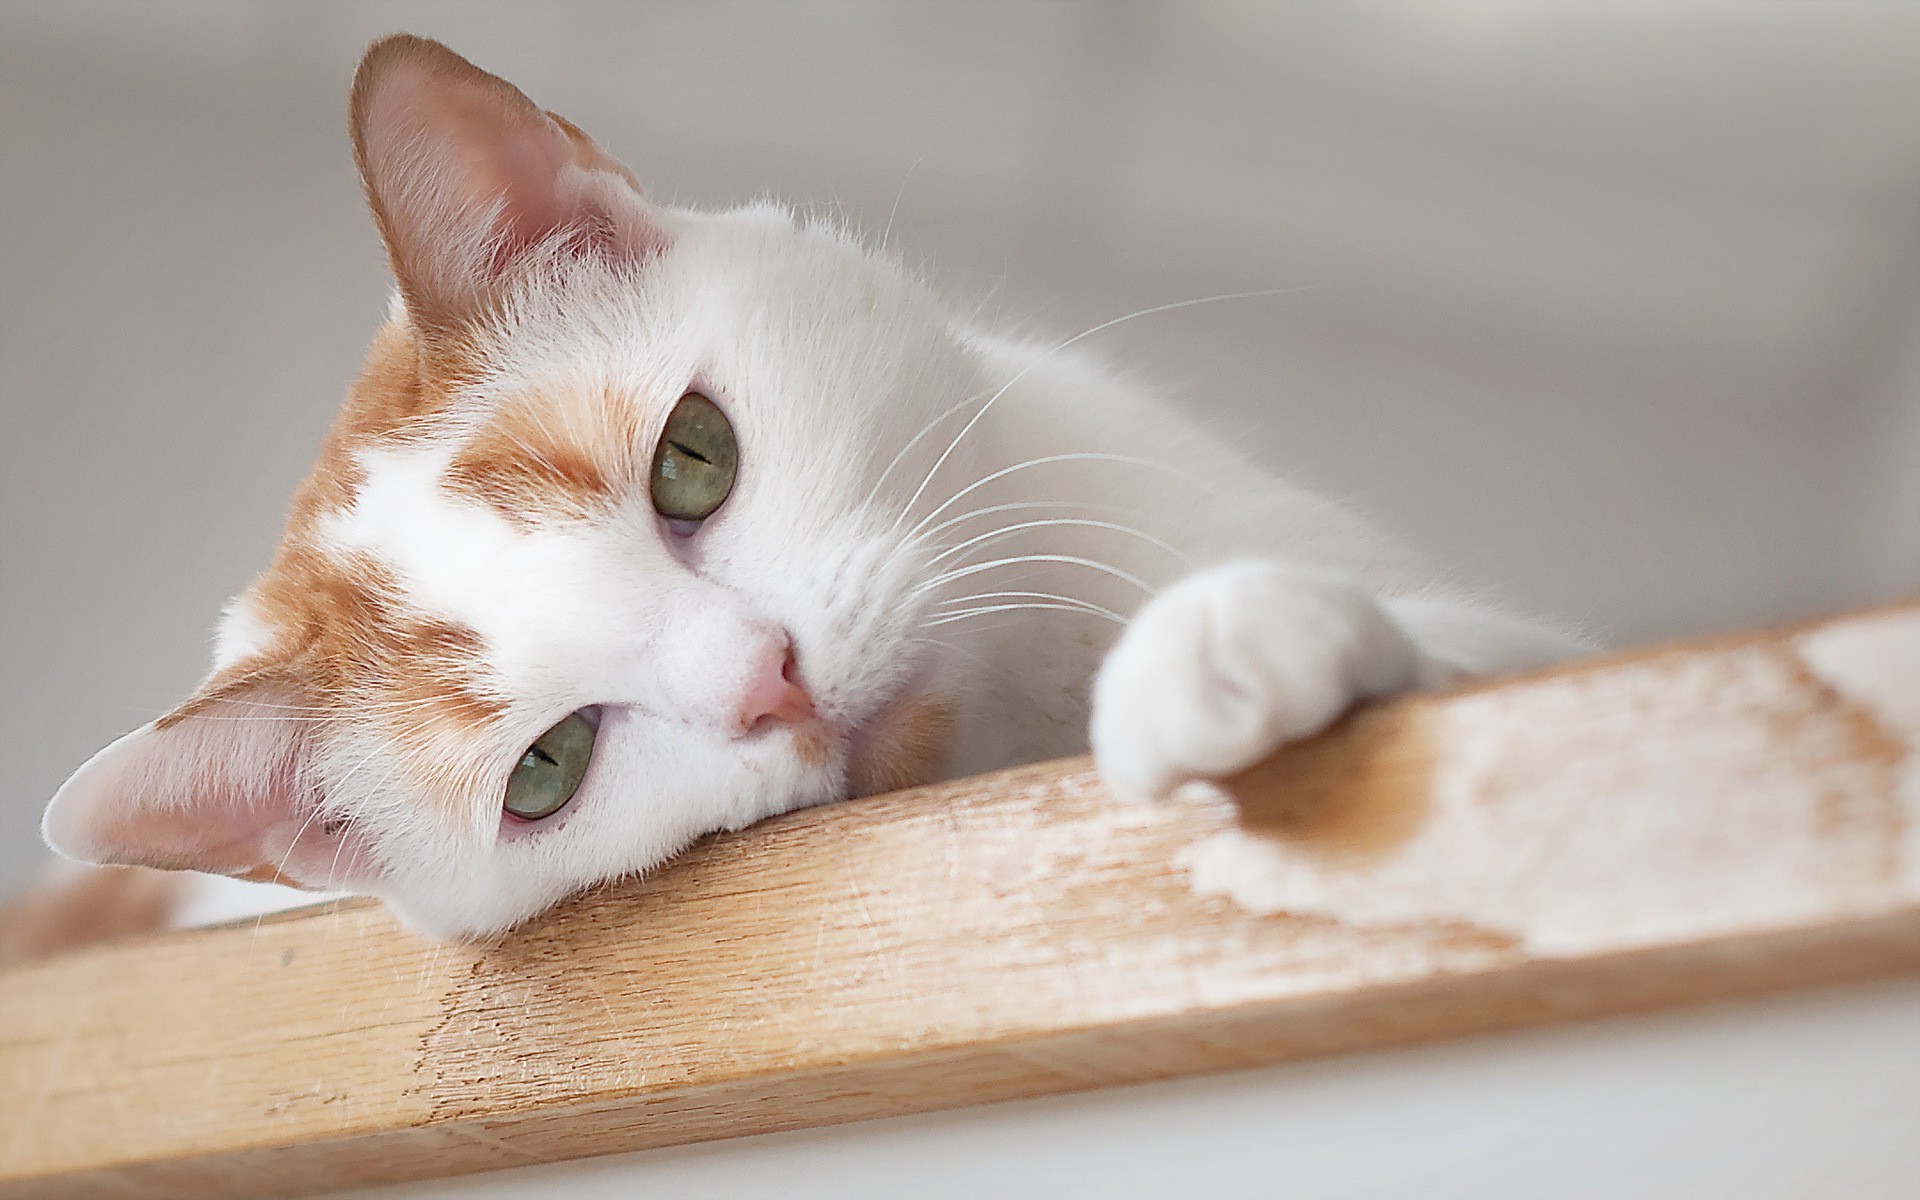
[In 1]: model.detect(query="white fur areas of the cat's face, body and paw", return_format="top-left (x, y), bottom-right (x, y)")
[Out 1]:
top-left (50, 185), bottom-right (1574, 937)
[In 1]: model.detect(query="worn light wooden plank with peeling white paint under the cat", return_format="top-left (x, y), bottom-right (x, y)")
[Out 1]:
top-left (0, 607), bottom-right (1920, 1200)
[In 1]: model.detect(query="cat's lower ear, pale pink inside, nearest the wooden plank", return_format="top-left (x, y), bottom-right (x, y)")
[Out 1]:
top-left (40, 668), bottom-right (371, 889)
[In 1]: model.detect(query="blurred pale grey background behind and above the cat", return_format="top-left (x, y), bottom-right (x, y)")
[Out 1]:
top-left (0, 0), bottom-right (1920, 1196)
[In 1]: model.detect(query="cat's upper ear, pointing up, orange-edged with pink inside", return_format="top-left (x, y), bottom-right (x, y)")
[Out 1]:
top-left (349, 35), bottom-right (664, 326)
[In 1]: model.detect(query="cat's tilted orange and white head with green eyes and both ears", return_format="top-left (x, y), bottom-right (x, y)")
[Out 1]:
top-left (46, 36), bottom-right (983, 937)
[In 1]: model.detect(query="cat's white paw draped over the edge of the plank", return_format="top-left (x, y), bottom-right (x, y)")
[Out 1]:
top-left (1091, 563), bottom-right (1425, 797)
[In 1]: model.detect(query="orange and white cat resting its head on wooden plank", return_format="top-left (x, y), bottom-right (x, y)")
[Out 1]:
top-left (33, 35), bottom-right (1582, 939)
